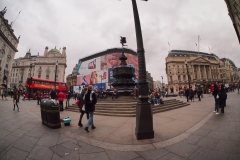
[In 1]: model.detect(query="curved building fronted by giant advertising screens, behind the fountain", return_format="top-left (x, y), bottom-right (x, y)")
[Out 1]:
top-left (67, 48), bottom-right (153, 92)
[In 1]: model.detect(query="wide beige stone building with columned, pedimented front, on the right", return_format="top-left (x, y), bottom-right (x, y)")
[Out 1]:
top-left (166, 50), bottom-right (237, 93)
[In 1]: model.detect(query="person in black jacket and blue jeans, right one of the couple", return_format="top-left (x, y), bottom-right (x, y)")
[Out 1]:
top-left (85, 85), bottom-right (97, 132)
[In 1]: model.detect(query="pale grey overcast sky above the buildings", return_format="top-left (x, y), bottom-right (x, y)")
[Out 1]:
top-left (0, 0), bottom-right (240, 82)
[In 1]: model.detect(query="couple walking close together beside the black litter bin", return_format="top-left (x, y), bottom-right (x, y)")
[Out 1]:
top-left (78, 85), bottom-right (97, 132)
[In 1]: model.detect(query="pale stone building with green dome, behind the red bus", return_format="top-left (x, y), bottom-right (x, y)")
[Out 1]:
top-left (10, 47), bottom-right (67, 87)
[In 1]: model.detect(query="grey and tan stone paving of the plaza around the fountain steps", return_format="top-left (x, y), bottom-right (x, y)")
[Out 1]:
top-left (0, 91), bottom-right (240, 160)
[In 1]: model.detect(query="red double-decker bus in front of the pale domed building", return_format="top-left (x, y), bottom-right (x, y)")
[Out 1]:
top-left (25, 77), bottom-right (67, 99)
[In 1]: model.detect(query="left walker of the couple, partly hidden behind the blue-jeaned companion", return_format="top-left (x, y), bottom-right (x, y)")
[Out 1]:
top-left (78, 87), bottom-right (89, 127)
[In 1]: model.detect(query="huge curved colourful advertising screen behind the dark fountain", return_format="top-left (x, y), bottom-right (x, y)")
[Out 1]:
top-left (77, 52), bottom-right (139, 90)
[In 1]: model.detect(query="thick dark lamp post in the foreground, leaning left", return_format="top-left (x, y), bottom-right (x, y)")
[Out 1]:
top-left (129, 0), bottom-right (154, 140)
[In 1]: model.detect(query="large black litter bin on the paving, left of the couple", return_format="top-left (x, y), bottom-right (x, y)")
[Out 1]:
top-left (41, 99), bottom-right (61, 129)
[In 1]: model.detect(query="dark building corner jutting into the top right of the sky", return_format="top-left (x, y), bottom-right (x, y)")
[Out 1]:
top-left (225, 0), bottom-right (240, 42)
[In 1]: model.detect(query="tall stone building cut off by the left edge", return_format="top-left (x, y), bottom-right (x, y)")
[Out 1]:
top-left (0, 7), bottom-right (20, 88)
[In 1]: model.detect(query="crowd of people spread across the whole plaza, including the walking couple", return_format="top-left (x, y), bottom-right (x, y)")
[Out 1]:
top-left (1, 84), bottom-right (239, 132)
